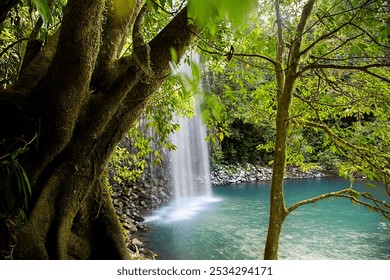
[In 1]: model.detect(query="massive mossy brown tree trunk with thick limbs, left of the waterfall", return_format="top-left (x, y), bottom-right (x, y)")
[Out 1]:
top-left (0, 0), bottom-right (195, 259)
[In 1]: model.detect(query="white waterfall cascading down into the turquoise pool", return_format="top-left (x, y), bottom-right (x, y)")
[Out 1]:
top-left (146, 108), bottom-right (219, 222)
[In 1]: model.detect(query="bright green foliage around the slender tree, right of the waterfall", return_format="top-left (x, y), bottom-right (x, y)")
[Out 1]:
top-left (200, 1), bottom-right (390, 189)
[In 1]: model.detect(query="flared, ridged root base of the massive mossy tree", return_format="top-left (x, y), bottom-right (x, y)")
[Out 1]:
top-left (14, 164), bottom-right (130, 259)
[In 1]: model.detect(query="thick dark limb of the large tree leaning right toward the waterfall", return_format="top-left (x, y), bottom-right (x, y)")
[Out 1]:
top-left (85, 5), bottom-right (197, 164)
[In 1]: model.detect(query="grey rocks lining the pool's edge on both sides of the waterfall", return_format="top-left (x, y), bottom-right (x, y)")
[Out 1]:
top-left (110, 164), bottom-right (329, 258)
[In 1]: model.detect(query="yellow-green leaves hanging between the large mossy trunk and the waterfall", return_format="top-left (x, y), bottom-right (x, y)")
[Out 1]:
top-left (110, 68), bottom-right (195, 184)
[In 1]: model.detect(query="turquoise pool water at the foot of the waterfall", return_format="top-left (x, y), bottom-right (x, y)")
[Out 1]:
top-left (142, 178), bottom-right (390, 260)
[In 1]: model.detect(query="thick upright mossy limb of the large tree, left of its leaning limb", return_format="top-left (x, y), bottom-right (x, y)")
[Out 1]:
top-left (32, 0), bottom-right (106, 173)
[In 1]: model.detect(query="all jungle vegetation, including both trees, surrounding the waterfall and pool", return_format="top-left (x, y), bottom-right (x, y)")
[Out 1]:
top-left (0, 0), bottom-right (390, 259)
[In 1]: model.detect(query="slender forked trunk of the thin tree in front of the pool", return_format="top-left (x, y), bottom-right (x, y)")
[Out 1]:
top-left (264, 0), bottom-right (315, 260)
